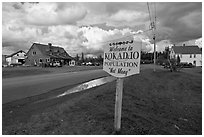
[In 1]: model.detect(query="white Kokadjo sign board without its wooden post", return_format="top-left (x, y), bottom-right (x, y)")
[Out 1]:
top-left (103, 36), bottom-right (142, 78)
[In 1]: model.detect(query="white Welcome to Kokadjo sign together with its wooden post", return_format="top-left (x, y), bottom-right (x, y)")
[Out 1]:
top-left (103, 37), bottom-right (142, 133)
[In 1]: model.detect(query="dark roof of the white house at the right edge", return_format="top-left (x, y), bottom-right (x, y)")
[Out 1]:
top-left (172, 46), bottom-right (202, 54)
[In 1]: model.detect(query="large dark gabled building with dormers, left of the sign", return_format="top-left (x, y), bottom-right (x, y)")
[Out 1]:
top-left (25, 43), bottom-right (72, 66)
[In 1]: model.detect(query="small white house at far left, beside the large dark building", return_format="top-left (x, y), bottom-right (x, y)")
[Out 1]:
top-left (6, 50), bottom-right (26, 65)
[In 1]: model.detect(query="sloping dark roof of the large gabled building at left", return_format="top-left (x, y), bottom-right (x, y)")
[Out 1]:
top-left (33, 43), bottom-right (72, 59)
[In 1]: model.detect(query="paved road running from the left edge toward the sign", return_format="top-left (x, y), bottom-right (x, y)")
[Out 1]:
top-left (2, 69), bottom-right (108, 104)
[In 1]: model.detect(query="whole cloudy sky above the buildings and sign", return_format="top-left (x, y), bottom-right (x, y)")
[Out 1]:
top-left (2, 2), bottom-right (202, 56)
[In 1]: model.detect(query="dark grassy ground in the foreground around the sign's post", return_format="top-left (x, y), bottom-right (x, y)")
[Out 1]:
top-left (2, 65), bottom-right (202, 135)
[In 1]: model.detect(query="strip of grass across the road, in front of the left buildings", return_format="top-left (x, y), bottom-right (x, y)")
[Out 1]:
top-left (2, 66), bottom-right (102, 78)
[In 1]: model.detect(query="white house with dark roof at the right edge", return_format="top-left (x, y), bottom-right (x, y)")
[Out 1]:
top-left (170, 46), bottom-right (202, 66)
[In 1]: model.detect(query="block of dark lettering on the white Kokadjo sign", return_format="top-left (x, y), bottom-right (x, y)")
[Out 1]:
top-left (104, 41), bottom-right (140, 75)
